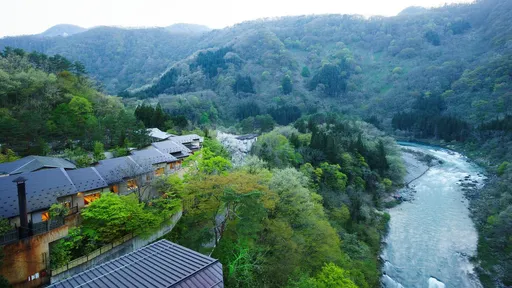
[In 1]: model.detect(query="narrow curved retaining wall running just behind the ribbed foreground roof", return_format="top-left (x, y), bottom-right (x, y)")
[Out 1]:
top-left (50, 211), bottom-right (182, 284)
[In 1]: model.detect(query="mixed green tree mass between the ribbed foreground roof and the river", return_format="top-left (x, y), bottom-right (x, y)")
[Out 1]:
top-left (167, 114), bottom-right (405, 287)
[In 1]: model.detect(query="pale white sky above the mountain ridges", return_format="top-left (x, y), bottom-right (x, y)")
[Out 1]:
top-left (0, 0), bottom-right (472, 37)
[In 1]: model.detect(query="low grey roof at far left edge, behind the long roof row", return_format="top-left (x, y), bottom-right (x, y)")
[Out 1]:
top-left (0, 156), bottom-right (76, 175)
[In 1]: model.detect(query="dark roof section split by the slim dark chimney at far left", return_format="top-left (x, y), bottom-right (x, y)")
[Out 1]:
top-left (0, 168), bottom-right (78, 218)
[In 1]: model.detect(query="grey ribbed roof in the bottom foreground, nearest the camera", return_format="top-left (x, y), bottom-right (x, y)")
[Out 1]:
top-left (50, 240), bottom-right (224, 288)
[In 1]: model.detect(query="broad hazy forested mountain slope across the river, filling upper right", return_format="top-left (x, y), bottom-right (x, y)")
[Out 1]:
top-left (127, 0), bottom-right (512, 127)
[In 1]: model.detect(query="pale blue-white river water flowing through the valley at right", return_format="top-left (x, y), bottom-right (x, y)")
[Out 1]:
top-left (382, 144), bottom-right (485, 288)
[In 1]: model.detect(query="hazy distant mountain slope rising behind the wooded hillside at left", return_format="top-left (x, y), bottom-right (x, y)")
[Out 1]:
top-left (0, 24), bottom-right (206, 93)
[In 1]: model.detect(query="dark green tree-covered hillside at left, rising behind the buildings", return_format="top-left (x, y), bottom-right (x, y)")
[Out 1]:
top-left (0, 49), bottom-right (147, 158)
